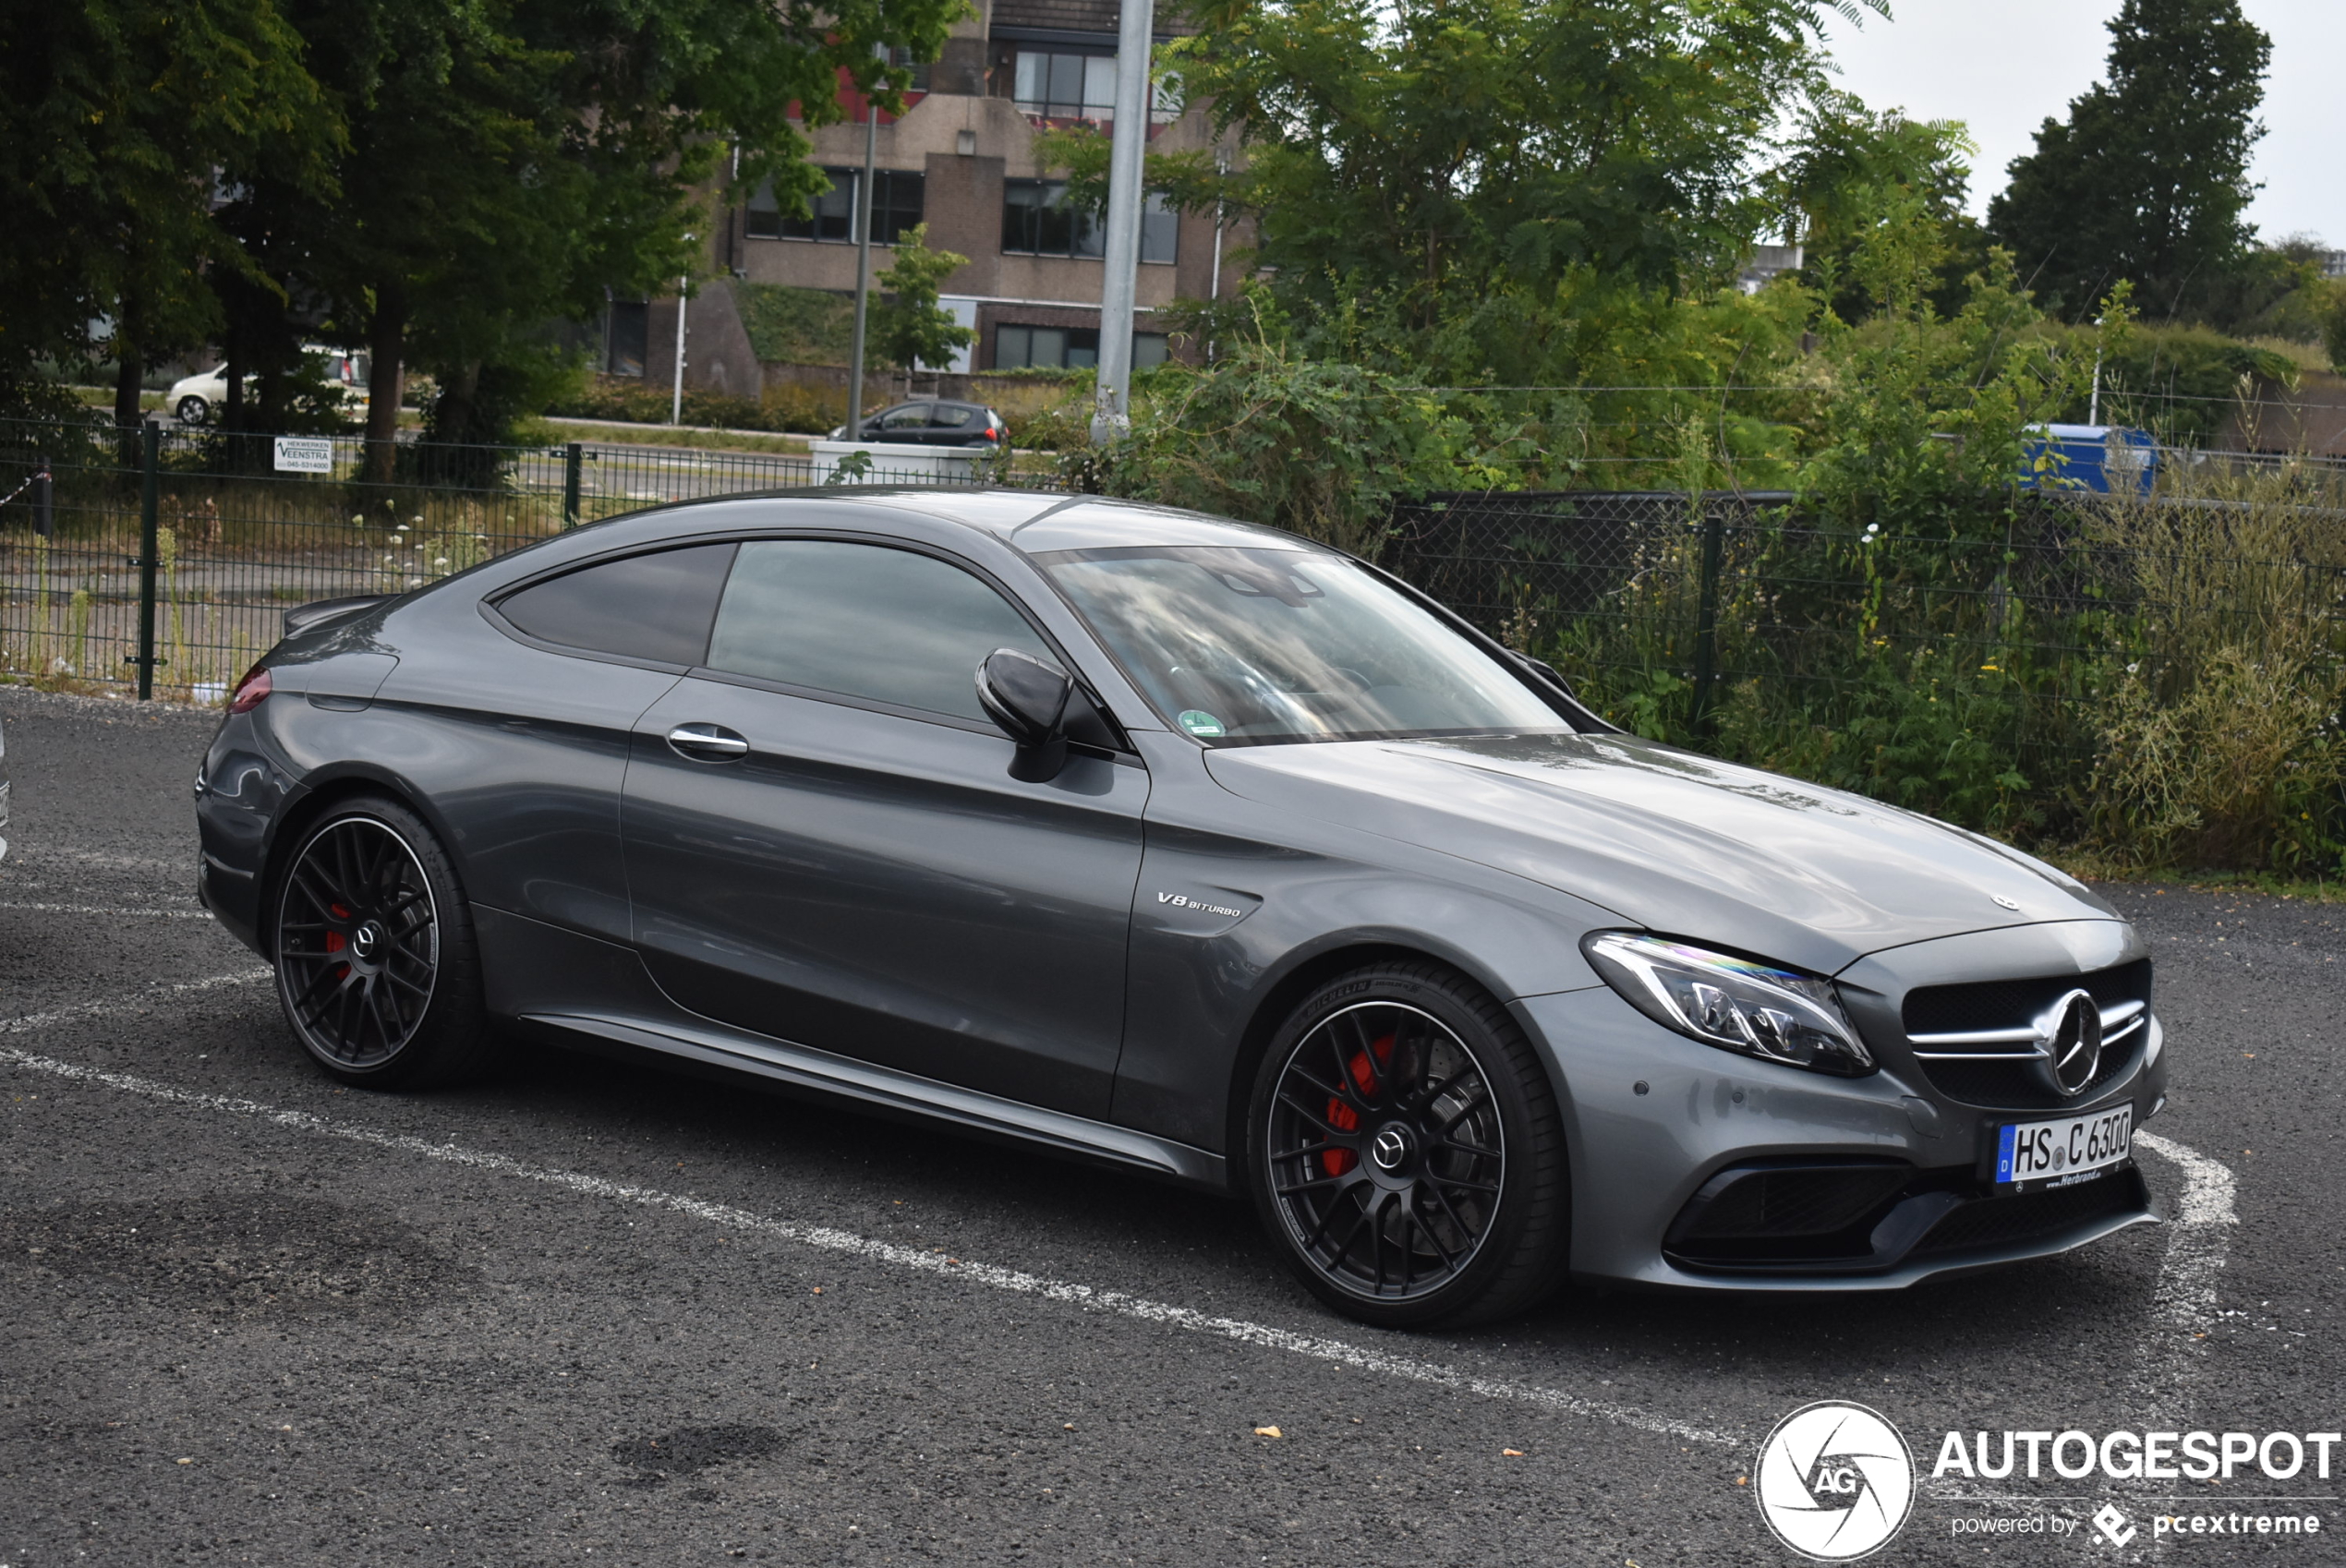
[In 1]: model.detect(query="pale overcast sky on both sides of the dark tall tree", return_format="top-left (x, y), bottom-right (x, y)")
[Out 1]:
top-left (1832, 0), bottom-right (2346, 247)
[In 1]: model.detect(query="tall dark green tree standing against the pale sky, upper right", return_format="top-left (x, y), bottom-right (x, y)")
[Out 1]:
top-left (1987, 0), bottom-right (2273, 319)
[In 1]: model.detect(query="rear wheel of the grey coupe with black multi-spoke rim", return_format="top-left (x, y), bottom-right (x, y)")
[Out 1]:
top-left (270, 794), bottom-right (502, 1090)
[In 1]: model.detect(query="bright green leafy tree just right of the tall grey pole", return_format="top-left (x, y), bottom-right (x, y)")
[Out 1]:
top-left (1156, 0), bottom-right (1881, 380)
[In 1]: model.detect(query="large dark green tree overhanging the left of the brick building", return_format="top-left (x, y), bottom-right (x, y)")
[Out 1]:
top-left (230, 0), bottom-right (961, 480)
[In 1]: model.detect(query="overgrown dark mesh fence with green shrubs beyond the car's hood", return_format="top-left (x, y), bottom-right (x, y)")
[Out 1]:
top-left (1386, 492), bottom-right (2346, 825)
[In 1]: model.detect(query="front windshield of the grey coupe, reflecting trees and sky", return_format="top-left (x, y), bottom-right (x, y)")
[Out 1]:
top-left (1037, 546), bottom-right (1569, 743)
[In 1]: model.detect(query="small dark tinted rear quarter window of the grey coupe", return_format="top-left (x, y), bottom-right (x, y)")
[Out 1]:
top-left (497, 544), bottom-right (734, 666)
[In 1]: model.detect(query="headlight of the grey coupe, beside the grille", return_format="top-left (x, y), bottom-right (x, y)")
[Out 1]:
top-left (1581, 931), bottom-right (1874, 1079)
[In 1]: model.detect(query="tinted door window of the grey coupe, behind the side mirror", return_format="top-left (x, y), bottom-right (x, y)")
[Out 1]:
top-left (708, 539), bottom-right (1056, 719)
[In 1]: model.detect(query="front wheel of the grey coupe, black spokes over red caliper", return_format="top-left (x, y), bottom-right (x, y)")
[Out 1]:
top-left (1246, 961), bottom-right (1572, 1329)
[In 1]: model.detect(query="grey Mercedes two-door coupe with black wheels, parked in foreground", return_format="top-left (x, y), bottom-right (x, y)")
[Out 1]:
top-left (197, 489), bottom-right (2165, 1327)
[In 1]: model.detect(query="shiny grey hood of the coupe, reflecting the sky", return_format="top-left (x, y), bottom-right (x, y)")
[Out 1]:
top-left (1206, 736), bottom-right (2119, 975)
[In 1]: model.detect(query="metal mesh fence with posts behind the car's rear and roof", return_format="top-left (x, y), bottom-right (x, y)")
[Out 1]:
top-left (0, 422), bottom-right (1048, 701)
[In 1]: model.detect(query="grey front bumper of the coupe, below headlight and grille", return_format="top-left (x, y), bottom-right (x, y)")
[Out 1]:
top-left (1513, 987), bottom-right (2165, 1292)
